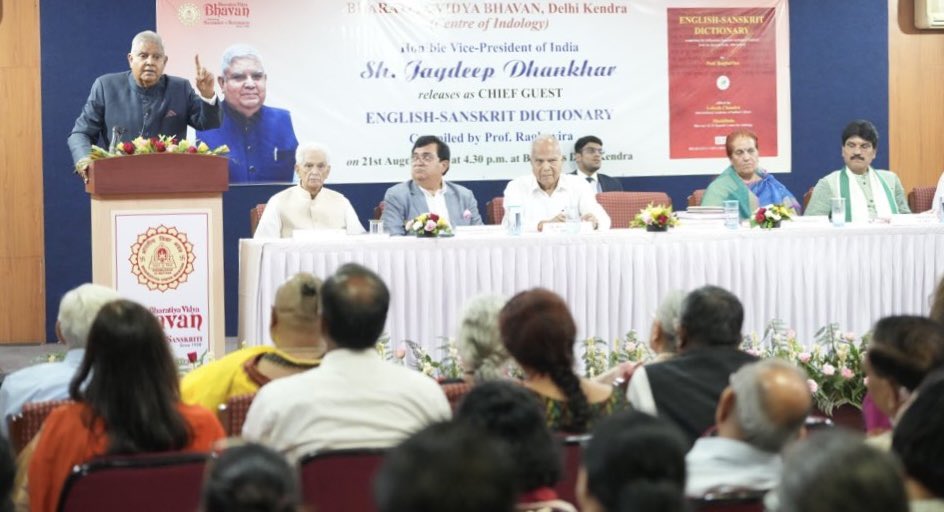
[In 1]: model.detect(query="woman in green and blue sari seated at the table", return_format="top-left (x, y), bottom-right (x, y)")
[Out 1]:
top-left (701, 129), bottom-right (802, 219)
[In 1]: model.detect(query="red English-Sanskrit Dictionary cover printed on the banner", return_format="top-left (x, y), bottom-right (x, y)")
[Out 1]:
top-left (667, 8), bottom-right (778, 159)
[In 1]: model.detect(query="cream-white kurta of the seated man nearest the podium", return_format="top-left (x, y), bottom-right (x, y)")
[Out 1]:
top-left (253, 185), bottom-right (365, 238)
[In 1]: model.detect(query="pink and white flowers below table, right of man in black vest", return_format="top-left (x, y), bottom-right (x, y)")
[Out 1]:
top-left (741, 320), bottom-right (870, 416)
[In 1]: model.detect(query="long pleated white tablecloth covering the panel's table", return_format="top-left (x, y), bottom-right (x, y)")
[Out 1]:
top-left (239, 218), bottom-right (944, 356)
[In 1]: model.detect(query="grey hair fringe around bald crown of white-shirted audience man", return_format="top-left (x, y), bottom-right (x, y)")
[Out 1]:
top-left (731, 358), bottom-right (807, 453)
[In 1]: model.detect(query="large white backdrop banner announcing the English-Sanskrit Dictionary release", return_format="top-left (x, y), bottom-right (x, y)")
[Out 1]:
top-left (157, 0), bottom-right (791, 183)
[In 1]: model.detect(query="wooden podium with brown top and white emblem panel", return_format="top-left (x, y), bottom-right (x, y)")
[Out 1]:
top-left (85, 153), bottom-right (229, 360)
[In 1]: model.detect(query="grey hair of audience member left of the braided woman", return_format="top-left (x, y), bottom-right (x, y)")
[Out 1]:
top-left (456, 295), bottom-right (511, 381)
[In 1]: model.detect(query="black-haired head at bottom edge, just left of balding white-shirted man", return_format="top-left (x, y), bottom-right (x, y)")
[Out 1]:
top-left (577, 411), bottom-right (687, 512)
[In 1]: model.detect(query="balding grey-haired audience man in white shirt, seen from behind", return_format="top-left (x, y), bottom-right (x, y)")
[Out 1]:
top-left (685, 359), bottom-right (813, 497)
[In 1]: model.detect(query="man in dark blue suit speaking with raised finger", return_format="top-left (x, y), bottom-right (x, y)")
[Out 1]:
top-left (69, 31), bottom-right (221, 181)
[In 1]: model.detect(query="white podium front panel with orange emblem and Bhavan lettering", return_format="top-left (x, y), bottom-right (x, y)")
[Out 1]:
top-left (113, 210), bottom-right (211, 364)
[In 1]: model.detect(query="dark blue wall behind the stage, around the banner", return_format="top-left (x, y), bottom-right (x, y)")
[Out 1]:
top-left (40, 0), bottom-right (888, 340)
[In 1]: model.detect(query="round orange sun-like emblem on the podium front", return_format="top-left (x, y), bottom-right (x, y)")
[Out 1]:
top-left (128, 225), bottom-right (196, 292)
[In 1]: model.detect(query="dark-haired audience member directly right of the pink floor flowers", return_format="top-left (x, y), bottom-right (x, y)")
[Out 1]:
top-left (865, 316), bottom-right (944, 450)
